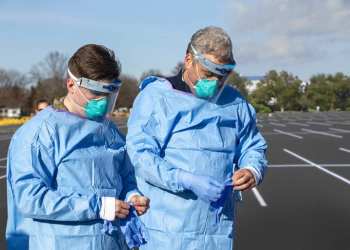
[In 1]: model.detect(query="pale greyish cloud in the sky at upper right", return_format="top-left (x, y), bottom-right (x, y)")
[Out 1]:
top-left (226, 0), bottom-right (350, 64)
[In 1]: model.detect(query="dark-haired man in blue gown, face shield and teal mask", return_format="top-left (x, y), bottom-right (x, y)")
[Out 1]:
top-left (6, 44), bottom-right (149, 250)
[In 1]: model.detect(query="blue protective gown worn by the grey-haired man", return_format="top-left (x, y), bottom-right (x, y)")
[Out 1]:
top-left (127, 78), bottom-right (267, 250)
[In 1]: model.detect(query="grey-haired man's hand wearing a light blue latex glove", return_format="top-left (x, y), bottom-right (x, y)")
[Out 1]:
top-left (178, 169), bottom-right (224, 202)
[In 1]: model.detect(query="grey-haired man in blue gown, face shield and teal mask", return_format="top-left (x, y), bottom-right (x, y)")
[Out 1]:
top-left (126, 27), bottom-right (267, 250)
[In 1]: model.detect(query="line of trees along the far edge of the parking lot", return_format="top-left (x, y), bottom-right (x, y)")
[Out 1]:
top-left (0, 51), bottom-right (350, 114)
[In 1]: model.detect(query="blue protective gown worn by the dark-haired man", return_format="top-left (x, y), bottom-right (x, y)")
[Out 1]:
top-left (6, 107), bottom-right (136, 250)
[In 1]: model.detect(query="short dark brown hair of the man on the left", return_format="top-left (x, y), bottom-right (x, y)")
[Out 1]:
top-left (68, 44), bottom-right (121, 81)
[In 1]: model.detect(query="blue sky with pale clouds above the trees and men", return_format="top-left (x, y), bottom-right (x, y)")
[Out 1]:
top-left (0, 0), bottom-right (350, 80)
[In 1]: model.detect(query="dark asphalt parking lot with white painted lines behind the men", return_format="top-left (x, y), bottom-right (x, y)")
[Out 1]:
top-left (0, 112), bottom-right (350, 250)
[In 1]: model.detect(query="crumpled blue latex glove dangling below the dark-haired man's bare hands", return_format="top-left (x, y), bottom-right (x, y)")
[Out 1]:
top-left (119, 206), bottom-right (149, 248)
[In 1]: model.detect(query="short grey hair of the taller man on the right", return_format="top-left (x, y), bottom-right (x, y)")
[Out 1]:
top-left (187, 26), bottom-right (234, 63)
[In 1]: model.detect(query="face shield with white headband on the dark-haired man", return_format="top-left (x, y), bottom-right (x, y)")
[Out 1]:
top-left (68, 69), bottom-right (122, 114)
